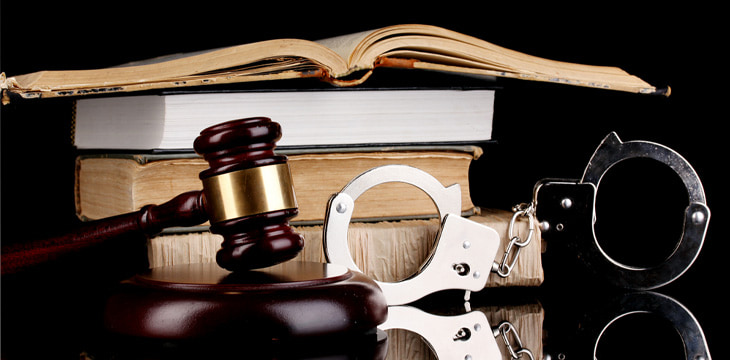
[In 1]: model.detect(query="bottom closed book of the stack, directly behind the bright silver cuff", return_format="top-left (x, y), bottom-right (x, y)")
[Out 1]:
top-left (148, 210), bottom-right (543, 287)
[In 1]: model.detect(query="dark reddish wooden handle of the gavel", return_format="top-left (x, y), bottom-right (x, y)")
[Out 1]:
top-left (0, 191), bottom-right (208, 275)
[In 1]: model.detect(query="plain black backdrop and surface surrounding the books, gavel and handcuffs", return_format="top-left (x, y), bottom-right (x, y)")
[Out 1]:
top-left (0, 2), bottom-right (728, 360)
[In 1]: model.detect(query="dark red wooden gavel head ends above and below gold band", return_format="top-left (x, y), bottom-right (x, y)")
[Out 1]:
top-left (194, 117), bottom-right (304, 271)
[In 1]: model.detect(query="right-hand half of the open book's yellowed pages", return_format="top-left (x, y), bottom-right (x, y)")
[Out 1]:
top-left (356, 25), bottom-right (656, 93)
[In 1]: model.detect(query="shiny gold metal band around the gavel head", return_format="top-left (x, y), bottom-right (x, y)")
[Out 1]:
top-left (203, 164), bottom-right (297, 223)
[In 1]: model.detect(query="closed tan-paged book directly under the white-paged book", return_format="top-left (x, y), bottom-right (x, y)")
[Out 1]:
top-left (75, 146), bottom-right (482, 223)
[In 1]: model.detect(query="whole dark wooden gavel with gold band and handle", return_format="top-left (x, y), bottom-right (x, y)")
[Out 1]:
top-left (2, 117), bottom-right (304, 274)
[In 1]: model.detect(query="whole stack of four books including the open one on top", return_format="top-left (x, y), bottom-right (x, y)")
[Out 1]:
top-left (25, 24), bottom-right (669, 286)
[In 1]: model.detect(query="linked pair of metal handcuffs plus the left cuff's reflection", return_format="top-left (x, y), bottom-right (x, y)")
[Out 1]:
top-left (323, 133), bottom-right (710, 359)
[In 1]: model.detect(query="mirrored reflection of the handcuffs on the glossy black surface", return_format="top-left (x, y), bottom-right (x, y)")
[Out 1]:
top-left (379, 291), bottom-right (712, 360)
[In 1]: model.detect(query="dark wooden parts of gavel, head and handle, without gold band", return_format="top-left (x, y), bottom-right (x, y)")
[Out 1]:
top-left (2, 117), bottom-right (304, 274)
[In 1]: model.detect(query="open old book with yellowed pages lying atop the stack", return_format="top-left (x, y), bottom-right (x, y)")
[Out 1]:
top-left (0, 24), bottom-right (663, 100)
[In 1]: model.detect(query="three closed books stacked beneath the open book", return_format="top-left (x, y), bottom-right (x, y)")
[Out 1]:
top-left (74, 87), bottom-right (542, 286)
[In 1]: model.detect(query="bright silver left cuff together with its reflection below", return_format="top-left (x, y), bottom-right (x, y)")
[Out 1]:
top-left (323, 165), bottom-right (516, 359)
